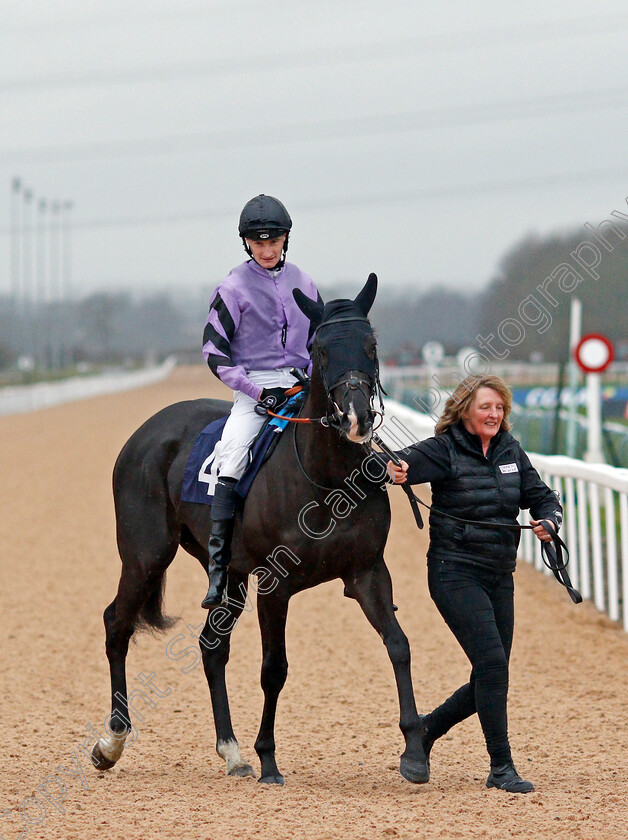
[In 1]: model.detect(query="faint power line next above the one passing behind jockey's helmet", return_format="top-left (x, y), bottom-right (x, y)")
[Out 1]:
top-left (0, 87), bottom-right (628, 164)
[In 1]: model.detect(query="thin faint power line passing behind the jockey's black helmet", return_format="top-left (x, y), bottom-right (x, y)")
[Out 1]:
top-left (0, 166), bottom-right (628, 235)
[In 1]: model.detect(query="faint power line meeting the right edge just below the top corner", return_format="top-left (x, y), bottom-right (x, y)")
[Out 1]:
top-left (0, 16), bottom-right (628, 94)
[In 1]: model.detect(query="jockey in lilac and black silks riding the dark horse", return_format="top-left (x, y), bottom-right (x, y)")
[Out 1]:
top-left (201, 195), bottom-right (321, 609)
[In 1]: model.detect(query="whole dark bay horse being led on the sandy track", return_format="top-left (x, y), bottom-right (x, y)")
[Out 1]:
top-left (92, 274), bottom-right (429, 784)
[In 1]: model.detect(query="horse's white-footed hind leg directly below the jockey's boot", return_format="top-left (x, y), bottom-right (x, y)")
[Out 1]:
top-left (199, 569), bottom-right (255, 778)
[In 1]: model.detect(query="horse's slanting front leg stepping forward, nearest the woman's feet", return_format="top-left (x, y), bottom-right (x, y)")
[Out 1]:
top-left (344, 558), bottom-right (430, 784)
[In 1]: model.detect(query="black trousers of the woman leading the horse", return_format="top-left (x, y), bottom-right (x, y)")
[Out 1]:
top-left (425, 560), bottom-right (514, 765)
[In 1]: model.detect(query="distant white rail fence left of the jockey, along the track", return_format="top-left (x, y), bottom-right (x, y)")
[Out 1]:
top-left (0, 357), bottom-right (176, 415)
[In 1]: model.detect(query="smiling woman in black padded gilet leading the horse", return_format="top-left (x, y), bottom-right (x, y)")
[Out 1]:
top-left (388, 376), bottom-right (562, 793)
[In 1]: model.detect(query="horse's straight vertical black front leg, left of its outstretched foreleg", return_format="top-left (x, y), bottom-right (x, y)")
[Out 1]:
top-left (255, 595), bottom-right (288, 785)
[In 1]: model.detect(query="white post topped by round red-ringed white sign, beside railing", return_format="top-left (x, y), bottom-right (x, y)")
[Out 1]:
top-left (574, 333), bottom-right (615, 463)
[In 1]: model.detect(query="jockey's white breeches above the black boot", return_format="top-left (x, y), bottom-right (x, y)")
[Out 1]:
top-left (218, 367), bottom-right (296, 478)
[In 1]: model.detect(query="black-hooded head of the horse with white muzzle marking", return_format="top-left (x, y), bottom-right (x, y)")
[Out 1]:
top-left (293, 274), bottom-right (380, 443)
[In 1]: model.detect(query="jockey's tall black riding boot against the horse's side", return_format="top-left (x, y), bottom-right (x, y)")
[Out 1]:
top-left (201, 478), bottom-right (236, 610)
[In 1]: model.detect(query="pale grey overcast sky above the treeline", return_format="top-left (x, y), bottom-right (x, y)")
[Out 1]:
top-left (0, 0), bottom-right (628, 302)
